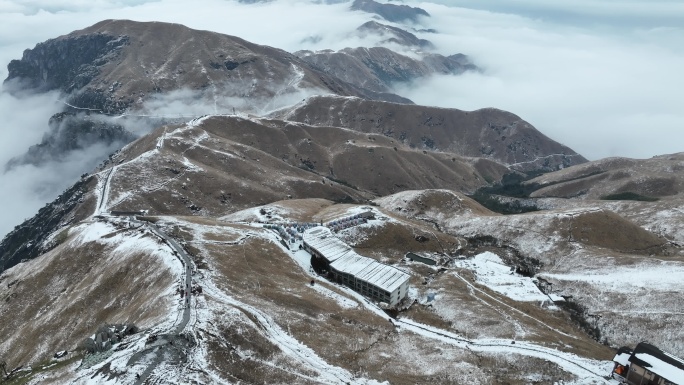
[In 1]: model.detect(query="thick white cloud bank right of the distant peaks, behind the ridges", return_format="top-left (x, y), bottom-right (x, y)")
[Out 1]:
top-left (398, 2), bottom-right (684, 159)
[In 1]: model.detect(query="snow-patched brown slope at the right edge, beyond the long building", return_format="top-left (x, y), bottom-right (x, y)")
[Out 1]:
top-left (378, 189), bottom-right (684, 354)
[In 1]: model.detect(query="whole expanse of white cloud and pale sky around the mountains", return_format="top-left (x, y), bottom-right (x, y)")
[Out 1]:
top-left (0, 0), bottom-right (684, 236)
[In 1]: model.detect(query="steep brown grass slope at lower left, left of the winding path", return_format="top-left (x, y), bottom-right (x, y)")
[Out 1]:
top-left (0, 224), bottom-right (175, 369)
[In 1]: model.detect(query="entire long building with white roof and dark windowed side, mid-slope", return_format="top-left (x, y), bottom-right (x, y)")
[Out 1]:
top-left (303, 226), bottom-right (410, 306)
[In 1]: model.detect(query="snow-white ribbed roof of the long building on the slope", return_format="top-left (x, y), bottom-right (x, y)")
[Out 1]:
top-left (304, 226), bottom-right (409, 293)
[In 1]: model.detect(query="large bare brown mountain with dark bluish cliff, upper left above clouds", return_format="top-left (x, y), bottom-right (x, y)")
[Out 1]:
top-left (6, 20), bottom-right (408, 113)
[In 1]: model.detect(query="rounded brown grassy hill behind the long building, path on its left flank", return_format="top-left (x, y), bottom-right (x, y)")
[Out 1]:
top-left (103, 116), bottom-right (506, 216)
